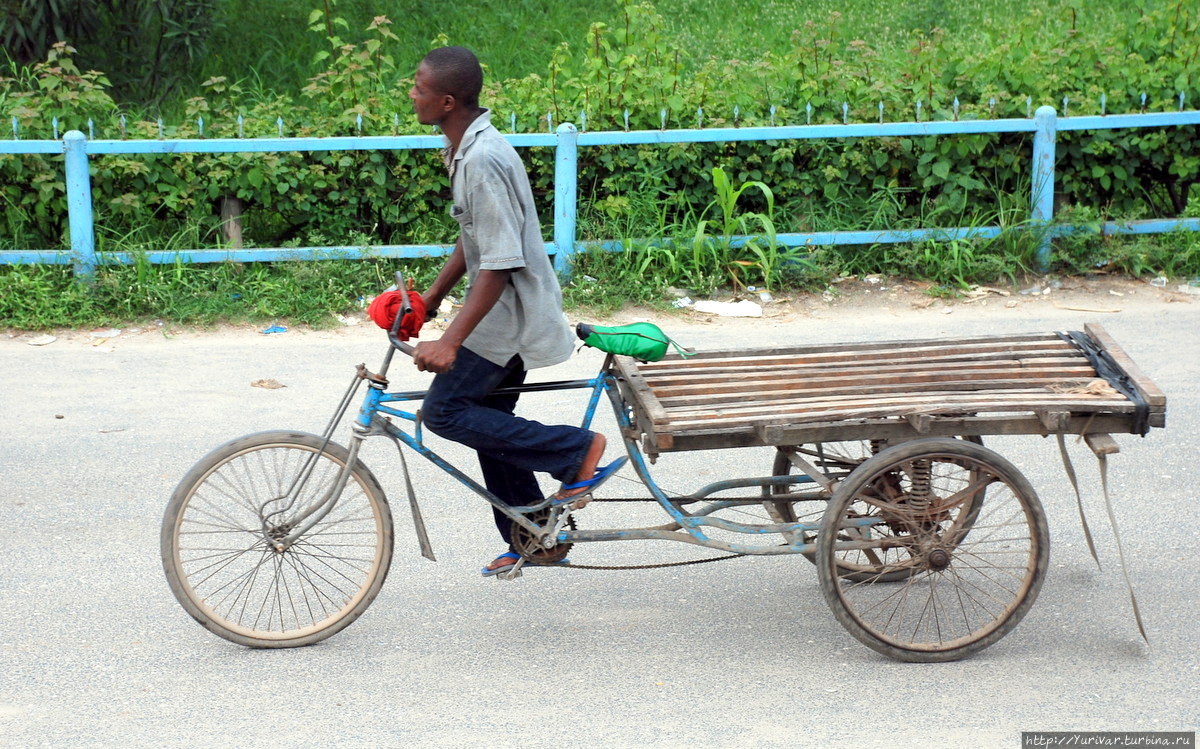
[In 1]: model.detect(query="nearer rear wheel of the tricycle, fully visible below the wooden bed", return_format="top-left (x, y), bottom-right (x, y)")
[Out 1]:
top-left (817, 439), bottom-right (1050, 663)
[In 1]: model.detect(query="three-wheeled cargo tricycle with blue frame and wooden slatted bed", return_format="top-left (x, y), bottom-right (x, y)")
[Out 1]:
top-left (161, 273), bottom-right (1165, 661)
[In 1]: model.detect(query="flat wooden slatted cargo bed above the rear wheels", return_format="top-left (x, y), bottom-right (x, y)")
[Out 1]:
top-left (613, 324), bottom-right (1166, 455)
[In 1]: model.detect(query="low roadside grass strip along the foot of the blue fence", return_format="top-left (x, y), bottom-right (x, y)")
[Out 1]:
top-left (0, 229), bottom-right (1200, 330)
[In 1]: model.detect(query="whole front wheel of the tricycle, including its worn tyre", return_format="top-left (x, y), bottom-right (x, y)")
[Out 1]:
top-left (161, 431), bottom-right (392, 648)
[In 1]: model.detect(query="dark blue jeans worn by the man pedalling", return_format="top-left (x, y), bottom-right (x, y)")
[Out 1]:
top-left (421, 348), bottom-right (593, 549)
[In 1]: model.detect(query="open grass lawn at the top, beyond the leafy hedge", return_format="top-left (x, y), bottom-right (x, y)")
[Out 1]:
top-left (192, 0), bottom-right (1129, 109)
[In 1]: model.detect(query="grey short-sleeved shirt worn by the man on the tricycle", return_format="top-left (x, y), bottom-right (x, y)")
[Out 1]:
top-left (446, 110), bottom-right (574, 370)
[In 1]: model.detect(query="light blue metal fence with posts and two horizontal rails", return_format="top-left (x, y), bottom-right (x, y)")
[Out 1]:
top-left (0, 107), bottom-right (1200, 278)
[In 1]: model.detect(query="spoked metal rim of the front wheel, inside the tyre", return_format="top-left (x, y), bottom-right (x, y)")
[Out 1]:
top-left (174, 443), bottom-right (386, 640)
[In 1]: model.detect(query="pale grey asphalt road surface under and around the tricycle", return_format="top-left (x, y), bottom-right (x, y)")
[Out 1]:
top-left (0, 286), bottom-right (1200, 747)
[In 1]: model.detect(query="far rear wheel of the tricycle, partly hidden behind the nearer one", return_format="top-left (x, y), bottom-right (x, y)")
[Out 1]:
top-left (763, 436), bottom-right (983, 582)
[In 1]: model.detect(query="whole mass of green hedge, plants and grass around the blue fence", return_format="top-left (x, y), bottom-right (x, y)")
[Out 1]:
top-left (0, 0), bottom-right (1200, 328)
